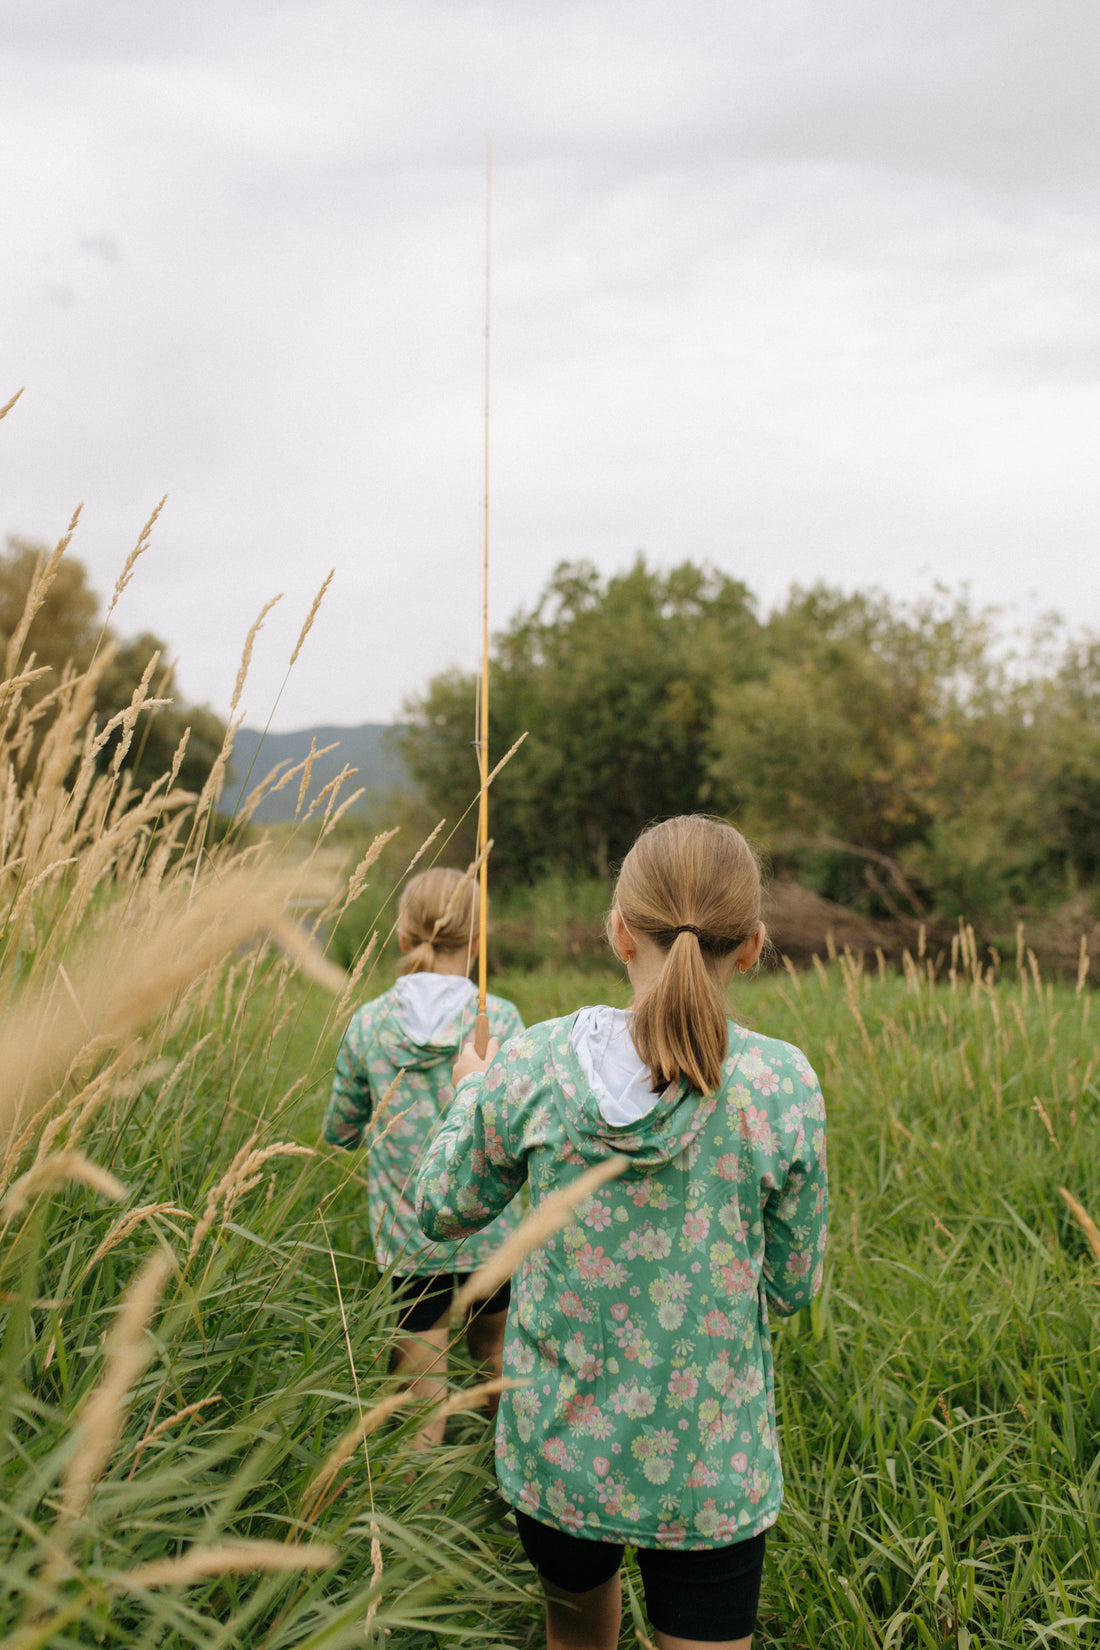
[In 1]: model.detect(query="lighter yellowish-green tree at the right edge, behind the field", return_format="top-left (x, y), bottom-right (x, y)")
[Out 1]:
top-left (709, 586), bottom-right (1100, 919)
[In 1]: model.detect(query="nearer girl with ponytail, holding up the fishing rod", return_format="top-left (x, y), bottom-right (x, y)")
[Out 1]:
top-left (417, 817), bottom-right (826, 1650)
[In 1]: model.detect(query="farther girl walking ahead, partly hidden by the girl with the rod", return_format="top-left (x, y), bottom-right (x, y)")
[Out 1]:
top-left (325, 868), bottom-right (523, 1445)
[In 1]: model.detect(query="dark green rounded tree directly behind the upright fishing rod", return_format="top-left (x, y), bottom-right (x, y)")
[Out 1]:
top-left (399, 556), bottom-right (762, 878)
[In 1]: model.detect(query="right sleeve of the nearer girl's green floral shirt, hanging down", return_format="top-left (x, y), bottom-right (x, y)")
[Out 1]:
top-left (764, 1066), bottom-right (828, 1317)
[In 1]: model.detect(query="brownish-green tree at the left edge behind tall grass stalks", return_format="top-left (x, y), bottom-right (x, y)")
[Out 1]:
top-left (0, 538), bottom-right (224, 790)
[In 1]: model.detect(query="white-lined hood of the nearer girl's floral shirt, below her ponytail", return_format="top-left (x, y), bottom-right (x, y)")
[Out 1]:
top-left (552, 1007), bottom-right (747, 1175)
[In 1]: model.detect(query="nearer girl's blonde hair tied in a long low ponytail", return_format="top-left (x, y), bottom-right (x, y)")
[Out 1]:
top-left (613, 813), bottom-right (762, 1094)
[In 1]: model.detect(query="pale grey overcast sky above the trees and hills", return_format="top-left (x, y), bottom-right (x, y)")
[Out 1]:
top-left (0, 0), bottom-right (1100, 729)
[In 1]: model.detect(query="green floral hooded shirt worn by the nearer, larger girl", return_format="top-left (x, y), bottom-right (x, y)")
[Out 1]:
top-left (416, 1015), bottom-right (828, 1549)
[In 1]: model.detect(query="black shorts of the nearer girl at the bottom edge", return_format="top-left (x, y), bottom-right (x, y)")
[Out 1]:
top-left (516, 1508), bottom-right (764, 1643)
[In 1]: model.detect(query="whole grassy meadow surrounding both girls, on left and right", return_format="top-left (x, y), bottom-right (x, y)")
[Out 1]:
top-left (0, 551), bottom-right (1100, 1650)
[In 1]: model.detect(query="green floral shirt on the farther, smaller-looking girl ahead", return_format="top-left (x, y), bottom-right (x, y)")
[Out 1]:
top-left (325, 990), bottom-right (523, 1277)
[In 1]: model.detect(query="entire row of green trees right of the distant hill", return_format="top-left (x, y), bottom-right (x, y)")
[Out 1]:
top-left (397, 556), bottom-right (1100, 919)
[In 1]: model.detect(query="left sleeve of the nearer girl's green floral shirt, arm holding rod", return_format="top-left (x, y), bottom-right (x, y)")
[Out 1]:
top-left (416, 1056), bottom-right (528, 1242)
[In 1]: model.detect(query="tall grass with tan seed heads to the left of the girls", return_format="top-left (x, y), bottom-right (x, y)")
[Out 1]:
top-left (0, 546), bottom-right (529, 1650)
